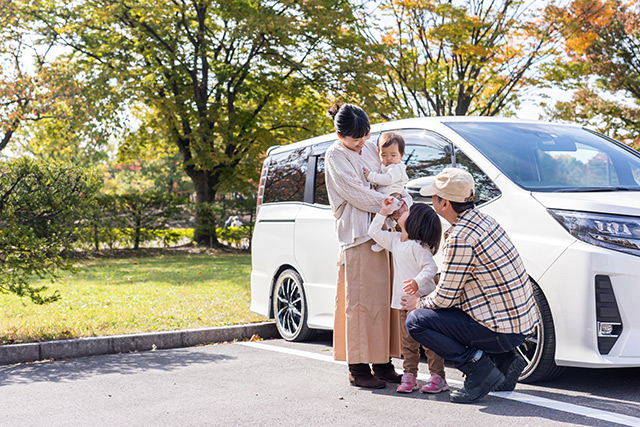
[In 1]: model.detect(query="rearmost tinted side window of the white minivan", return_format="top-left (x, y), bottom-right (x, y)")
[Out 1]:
top-left (262, 147), bottom-right (310, 203)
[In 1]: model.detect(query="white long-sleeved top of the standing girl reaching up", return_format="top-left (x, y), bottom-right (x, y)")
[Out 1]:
top-left (369, 214), bottom-right (438, 309)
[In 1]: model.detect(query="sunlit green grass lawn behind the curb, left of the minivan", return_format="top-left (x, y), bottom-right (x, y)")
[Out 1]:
top-left (0, 253), bottom-right (265, 344)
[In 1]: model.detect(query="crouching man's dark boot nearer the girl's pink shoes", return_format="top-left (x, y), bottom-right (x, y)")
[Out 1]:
top-left (450, 353), bottom-right (504, 403)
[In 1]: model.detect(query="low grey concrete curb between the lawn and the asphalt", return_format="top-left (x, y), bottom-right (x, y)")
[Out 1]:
top-left (0, 322), bottom-right (280, 365)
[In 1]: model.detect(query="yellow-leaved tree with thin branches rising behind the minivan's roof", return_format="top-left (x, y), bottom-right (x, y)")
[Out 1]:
top-left (369, 0), bottom-right (555, 116)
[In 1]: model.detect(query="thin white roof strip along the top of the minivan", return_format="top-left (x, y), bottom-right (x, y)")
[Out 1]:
top-left (267, 116), bottom-right (581, 155)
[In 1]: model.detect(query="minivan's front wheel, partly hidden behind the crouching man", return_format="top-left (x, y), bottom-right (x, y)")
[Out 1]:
top-left (516, 283), bottom-right (564, 383)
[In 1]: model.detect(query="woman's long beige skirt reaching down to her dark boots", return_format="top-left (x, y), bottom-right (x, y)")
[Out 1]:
top-left (333, 240), bottom-right (401, 364)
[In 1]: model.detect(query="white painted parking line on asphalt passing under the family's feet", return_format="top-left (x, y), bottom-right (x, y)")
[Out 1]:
top-left (238, 342), bottom-right (640, 427)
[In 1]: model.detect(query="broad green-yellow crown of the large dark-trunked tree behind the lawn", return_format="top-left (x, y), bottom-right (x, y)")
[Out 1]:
top-left (23, 0), bottom-right (376, 246)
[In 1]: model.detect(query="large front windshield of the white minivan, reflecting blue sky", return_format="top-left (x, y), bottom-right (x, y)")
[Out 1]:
top-left (445, 121), bottom-right (640, 192)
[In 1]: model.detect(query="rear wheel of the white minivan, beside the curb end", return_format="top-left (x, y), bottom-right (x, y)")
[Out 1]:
top-left (272, 269), bottom-right (316, 341)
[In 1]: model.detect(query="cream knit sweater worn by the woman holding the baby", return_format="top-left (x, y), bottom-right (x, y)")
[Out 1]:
top-left (325, 140), bottom-right (412, 248)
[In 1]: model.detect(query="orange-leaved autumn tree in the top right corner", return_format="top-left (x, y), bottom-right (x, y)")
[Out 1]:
top-left (547, 0), bottom-right (640, 148)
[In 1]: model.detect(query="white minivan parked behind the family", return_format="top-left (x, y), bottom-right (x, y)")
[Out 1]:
top-left (251, 117), bottom-right (640, 382)
